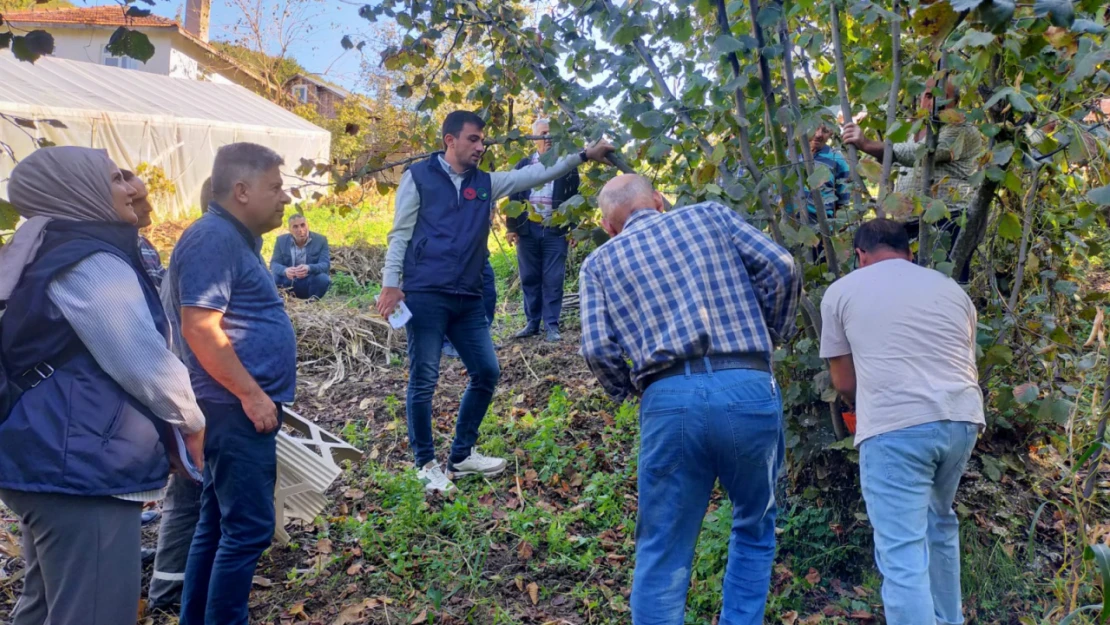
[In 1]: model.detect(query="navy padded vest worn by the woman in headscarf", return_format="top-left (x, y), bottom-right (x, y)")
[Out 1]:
top-left (0, 221), bottom-right (172, 496)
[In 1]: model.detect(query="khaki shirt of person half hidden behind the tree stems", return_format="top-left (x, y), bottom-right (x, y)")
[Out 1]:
top-left (894, 123), bottom-right (987, 211)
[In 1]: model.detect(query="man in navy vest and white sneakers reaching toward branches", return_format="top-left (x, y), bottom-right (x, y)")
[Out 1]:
top-left (377, 111), bottom-right (613, 492)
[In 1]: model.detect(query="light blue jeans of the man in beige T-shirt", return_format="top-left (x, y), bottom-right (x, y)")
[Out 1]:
top-left (859, 421), bottom-right (979, 625)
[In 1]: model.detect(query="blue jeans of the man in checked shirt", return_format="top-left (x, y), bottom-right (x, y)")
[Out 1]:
top-left (632, 370), bottom-right (785, 625)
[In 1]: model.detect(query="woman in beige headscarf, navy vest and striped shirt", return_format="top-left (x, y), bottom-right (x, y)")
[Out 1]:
top-left (0, 147), bottom-right (204, 625)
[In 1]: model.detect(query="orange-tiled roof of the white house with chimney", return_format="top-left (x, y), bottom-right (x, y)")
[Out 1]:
top-left (3, 4), bottom-right (270, 88)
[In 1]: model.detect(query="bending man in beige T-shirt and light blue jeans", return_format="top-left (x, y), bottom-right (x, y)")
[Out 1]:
top-left (820, 219), bottom-right (985, 625)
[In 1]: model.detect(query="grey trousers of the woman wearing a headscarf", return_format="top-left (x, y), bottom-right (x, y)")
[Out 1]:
top-left (0, 490), bottom-right (142, 625)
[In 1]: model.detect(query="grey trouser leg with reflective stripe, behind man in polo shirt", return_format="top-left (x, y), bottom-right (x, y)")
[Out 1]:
top-left (147, 474), bottom-right (203, 612)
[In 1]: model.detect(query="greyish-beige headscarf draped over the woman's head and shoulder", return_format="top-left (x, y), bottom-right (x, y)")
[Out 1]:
top-left (0, 145), bottom-right (120, 302)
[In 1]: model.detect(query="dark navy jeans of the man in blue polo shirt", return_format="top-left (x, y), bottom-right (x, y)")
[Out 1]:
top-left (181, 402), bottom-right (281, 625)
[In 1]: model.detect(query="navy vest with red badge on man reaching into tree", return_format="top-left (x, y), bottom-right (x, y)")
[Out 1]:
top-left (402, 153), bottom-right (493, 298)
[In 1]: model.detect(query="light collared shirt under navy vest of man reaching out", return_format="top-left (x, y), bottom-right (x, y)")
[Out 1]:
top-left (382, 154), bottom-right (582, 286)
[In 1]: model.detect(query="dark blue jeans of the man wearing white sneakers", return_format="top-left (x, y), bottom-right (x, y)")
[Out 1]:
top-left (405, 292), bottom-right (501, 466)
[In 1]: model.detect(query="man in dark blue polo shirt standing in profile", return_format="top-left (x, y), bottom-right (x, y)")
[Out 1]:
top-left (162, 143), bottom-right (296, 625)
